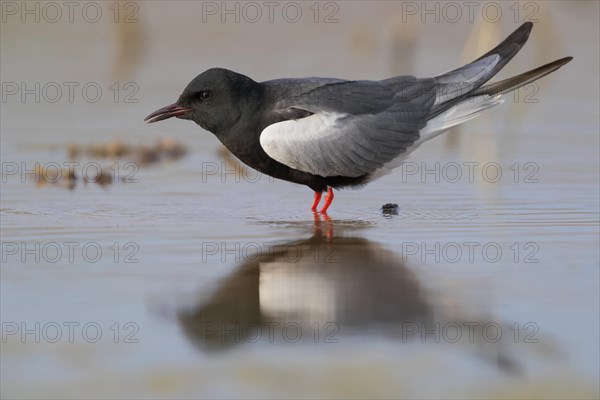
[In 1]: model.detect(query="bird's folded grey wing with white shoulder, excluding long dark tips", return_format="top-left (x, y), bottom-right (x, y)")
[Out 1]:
top-left (260, 76), bottom-right (436, 177)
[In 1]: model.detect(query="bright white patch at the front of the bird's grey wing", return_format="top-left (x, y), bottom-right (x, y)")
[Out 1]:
top-left (260, 112), bottom-right (348, 176)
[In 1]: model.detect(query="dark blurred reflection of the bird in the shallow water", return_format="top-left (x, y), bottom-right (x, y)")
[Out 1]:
top-left (178, 220), bottom-right (517, 372)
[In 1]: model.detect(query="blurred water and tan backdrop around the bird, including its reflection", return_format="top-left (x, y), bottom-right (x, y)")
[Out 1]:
top-left (0, 1), bottom-right (600, 398)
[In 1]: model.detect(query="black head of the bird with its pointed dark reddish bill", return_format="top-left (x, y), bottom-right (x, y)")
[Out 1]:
top-left (144, 68), bottom-right (260, 134)
